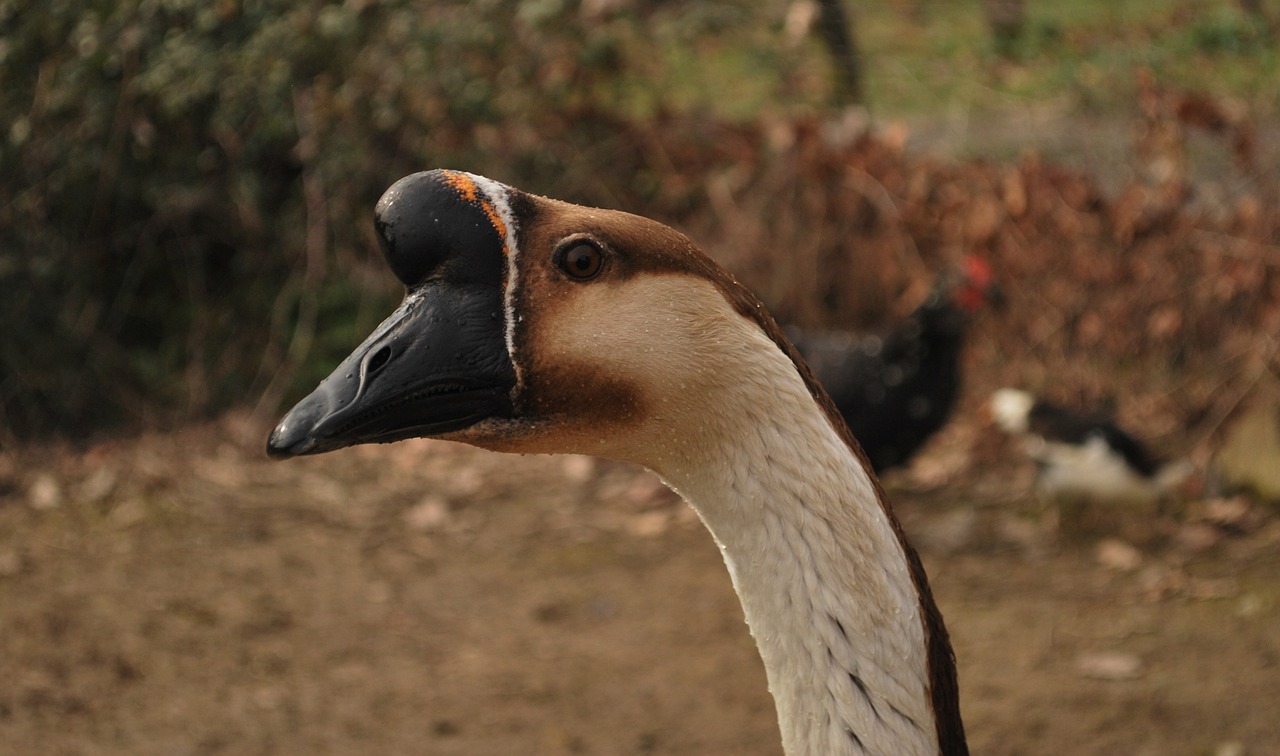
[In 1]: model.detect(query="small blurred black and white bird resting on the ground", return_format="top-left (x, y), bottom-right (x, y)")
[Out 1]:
top-left (988, 389), bottom-right (1192, 503)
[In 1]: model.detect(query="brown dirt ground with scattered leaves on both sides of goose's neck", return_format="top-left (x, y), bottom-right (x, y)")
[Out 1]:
top-left (0, 418), bottom-right (1280, 756)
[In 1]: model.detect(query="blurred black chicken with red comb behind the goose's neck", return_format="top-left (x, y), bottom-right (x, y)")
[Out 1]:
top-left (787, 256), bottom-right (1000, 472)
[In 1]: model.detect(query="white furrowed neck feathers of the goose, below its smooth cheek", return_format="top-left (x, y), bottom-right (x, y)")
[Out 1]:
top-left (664, 340), bottom-right (938, 755)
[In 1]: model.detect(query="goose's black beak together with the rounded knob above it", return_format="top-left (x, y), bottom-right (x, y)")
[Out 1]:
top-left (266, 170), bottom-right (520, 457)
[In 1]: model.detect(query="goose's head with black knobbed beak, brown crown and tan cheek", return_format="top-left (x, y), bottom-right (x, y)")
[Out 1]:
top-left (268, 170), bottom-right (815, 472)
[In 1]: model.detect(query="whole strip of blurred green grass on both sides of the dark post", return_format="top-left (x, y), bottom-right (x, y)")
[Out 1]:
top-left (628, 0), bottom-right (1280, 119)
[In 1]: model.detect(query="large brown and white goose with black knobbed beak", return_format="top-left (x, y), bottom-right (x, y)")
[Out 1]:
top-left (268, 170), bottom-right (968, 756)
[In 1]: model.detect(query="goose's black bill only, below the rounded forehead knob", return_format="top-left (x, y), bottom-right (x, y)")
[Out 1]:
top-left (266, 284), bottom-right (516, 457)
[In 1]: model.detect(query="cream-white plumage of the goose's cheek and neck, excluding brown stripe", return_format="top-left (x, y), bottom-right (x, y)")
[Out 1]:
top-left (529, 276), bottom-right (938, 756)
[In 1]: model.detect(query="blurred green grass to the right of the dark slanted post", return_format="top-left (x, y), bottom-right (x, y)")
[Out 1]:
top-left (859, 0), bottom-right (1280, 118)
